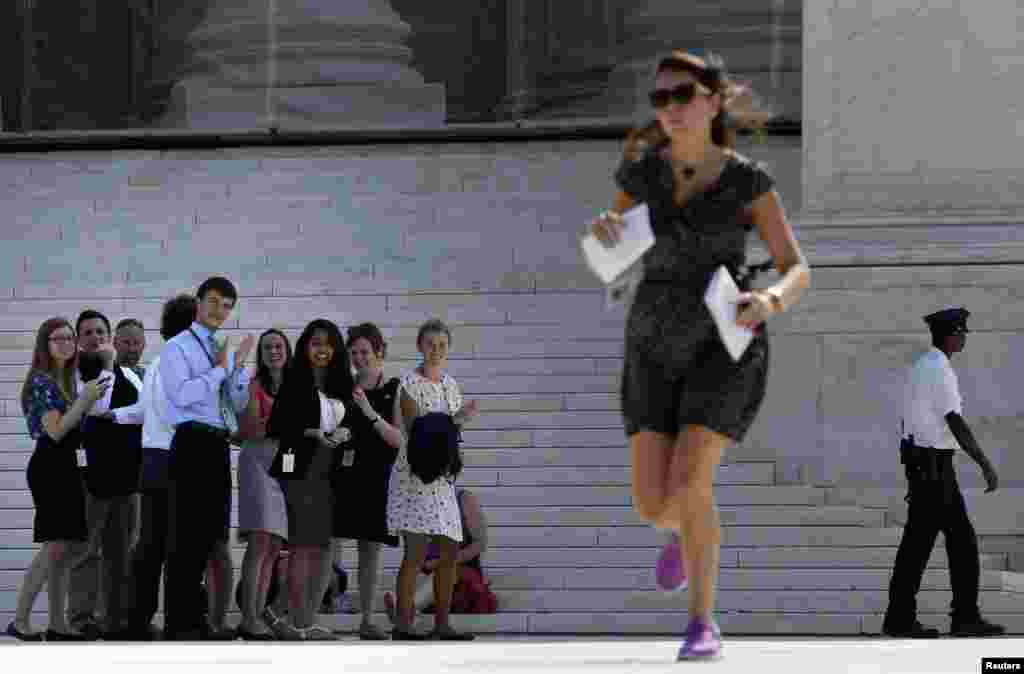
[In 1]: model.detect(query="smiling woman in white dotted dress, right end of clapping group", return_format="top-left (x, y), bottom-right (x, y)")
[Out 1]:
top-left (387, 320), bottom-right (479, 640)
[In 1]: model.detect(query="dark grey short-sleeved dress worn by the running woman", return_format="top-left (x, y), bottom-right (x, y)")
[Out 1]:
top-left (615, 144), bottom-right (773, 443)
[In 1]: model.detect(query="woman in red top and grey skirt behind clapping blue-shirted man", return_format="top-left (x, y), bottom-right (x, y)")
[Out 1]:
top-left (239, 329), bottom-right (292, 641)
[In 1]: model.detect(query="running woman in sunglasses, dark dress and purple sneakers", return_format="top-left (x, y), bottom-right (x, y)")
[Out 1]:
top-left (589, 51), bottom-right (810, 660)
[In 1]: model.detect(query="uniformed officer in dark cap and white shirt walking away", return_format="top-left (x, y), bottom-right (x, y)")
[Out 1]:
top-left (882, 308), bottom-right (1005, 638)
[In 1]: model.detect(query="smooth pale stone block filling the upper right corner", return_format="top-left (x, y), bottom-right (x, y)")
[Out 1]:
top-left (803, 0), bottom-right (1024, 219)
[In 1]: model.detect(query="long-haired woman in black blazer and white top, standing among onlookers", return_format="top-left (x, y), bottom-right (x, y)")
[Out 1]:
top-left (267, 319), bottom-right (355, 640)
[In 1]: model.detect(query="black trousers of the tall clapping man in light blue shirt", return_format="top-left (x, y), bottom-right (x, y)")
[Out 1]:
top-left (164, 424), bottom-right (231, 639)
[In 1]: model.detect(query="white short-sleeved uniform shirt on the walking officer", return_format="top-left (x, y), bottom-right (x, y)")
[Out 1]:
top-left (903, 346), bottom-right (964, 450)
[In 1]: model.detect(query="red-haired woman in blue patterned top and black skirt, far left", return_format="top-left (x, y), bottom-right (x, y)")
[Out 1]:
top-left (7, 318), bottom-right (110, 641)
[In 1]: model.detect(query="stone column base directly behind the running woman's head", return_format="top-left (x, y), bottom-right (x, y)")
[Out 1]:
top-left (591, 0), bottom-right (803, 120)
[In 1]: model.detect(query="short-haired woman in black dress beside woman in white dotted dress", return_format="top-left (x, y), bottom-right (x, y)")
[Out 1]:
top-left (334, 323), bottom-right (401, 640)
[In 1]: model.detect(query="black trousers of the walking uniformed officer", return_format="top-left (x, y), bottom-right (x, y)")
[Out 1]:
top-left (886, 458), bottom-right (981, 628)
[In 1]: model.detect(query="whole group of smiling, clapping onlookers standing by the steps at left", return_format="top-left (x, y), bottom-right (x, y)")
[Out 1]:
top-left (7, 277), bottom-right (495, 641)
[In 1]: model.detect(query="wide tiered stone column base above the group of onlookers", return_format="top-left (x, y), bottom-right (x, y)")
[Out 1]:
top-left (161, 0), bottom-right (444, 130)
